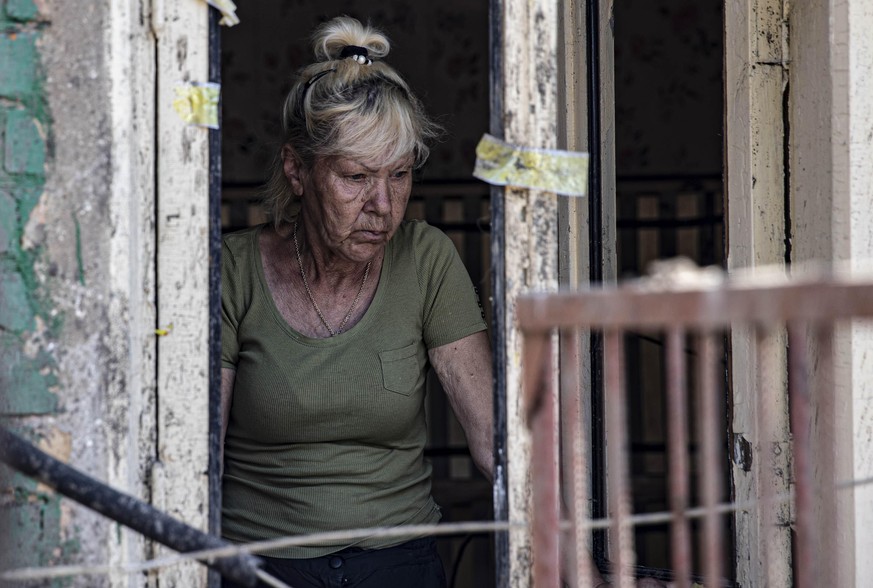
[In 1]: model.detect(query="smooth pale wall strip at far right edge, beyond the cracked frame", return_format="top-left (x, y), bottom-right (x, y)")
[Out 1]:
top-left (789, 0), bottom-right (873, 586)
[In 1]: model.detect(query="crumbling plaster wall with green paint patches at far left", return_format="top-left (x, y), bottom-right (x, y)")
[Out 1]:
top-left (0, 0), bottom-right (154, 586)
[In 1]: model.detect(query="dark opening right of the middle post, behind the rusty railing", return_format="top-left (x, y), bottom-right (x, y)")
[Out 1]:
top-left (608, 0), bottom-right (733, 577)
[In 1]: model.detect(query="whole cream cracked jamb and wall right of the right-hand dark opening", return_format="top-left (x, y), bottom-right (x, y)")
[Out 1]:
top-left (726, 0), bottom-right (873, 586)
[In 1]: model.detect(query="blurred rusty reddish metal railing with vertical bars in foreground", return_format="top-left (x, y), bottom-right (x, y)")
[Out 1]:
top-left (517, 270), bottom-right (873, 588)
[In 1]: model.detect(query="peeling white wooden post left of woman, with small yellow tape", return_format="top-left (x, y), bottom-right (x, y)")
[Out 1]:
top-left (151, 0), bottom-right (212, 586)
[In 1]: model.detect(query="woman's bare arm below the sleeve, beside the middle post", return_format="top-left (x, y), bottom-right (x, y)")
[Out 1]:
top-left (428, 331), bottom-right (494, 482)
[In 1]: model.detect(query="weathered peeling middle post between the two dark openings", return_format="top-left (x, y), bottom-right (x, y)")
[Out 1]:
top-left (491, 0), bottom-right (615, 586)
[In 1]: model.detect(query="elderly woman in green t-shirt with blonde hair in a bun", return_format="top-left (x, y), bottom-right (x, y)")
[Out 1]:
top-left (222, 17), bottom-right (493, 588)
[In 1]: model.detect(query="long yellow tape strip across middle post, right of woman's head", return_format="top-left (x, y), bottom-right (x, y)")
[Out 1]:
top-left (473, 133), bottom-right (588, 196)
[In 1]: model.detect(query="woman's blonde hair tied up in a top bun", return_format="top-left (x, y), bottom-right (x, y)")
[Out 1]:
top-left (264, 16), bottom-right (442, 226)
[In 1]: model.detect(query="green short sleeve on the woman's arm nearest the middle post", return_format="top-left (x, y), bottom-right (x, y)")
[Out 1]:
top-left (415, 223), bottom-right (487, 349)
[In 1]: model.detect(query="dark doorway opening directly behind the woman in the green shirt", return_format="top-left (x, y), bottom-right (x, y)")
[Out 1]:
top-left (221, 0), bottom-right (494, 588)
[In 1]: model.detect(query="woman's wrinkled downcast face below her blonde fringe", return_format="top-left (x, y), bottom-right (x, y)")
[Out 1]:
top-left (289, 150), bottom-right (413, 262)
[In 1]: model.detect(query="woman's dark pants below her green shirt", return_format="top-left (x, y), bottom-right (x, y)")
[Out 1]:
top-left (221, 537), bottom-right (446, 588)
